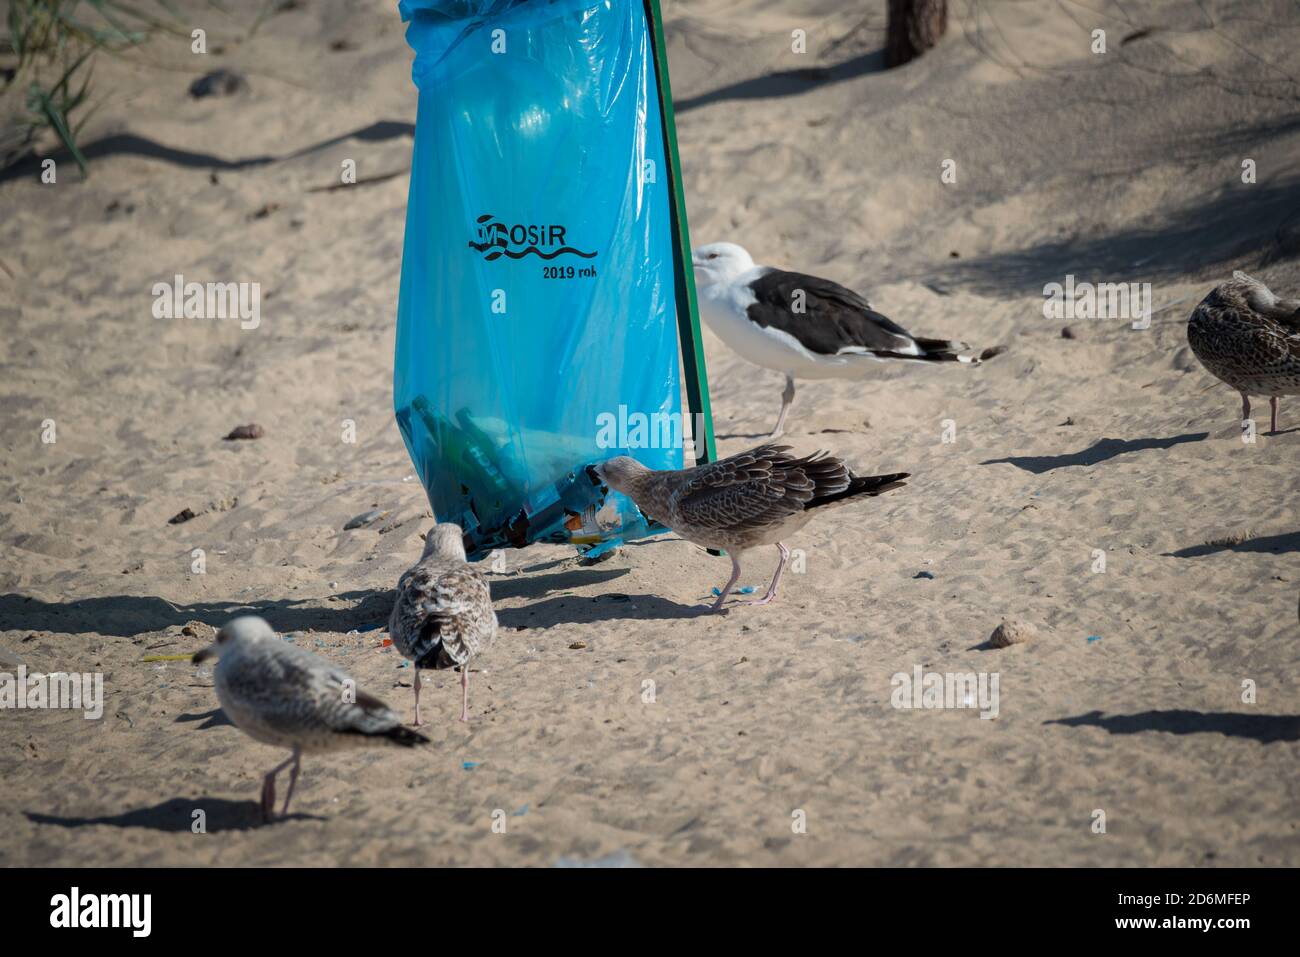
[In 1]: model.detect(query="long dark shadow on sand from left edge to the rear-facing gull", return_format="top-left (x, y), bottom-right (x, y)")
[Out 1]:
top-left (0, 589), bottom-right (393, 638)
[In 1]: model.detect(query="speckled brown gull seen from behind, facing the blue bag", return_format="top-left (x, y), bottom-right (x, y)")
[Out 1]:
top-left (389, 523), bottom-right (497, 727)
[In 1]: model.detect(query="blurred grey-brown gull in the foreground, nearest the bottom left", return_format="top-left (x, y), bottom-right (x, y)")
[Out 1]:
top-left (192, 615), bottom-right (429, 820)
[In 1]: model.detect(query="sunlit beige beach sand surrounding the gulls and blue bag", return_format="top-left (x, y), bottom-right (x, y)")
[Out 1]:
top-left (0, 0), bottom-right (1300, 866)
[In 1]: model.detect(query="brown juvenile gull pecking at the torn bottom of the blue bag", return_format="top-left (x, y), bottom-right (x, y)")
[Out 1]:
top-left (588, 445), bottom-right (907, 611)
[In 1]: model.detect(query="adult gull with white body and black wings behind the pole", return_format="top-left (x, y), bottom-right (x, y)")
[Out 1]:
top-left (692, 243), bottom-right (1001, 439)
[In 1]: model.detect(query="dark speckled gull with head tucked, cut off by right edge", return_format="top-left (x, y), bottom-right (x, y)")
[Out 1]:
top-left (1187, 272), bottom-right (1300, 432)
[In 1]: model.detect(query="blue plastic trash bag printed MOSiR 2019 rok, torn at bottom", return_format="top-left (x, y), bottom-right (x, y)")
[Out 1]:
top-left (393, 0), bottom-right (683, 558)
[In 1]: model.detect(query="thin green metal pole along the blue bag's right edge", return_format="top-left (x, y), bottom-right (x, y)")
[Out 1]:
top-left (645, 0), bottom-right (718, 464)
